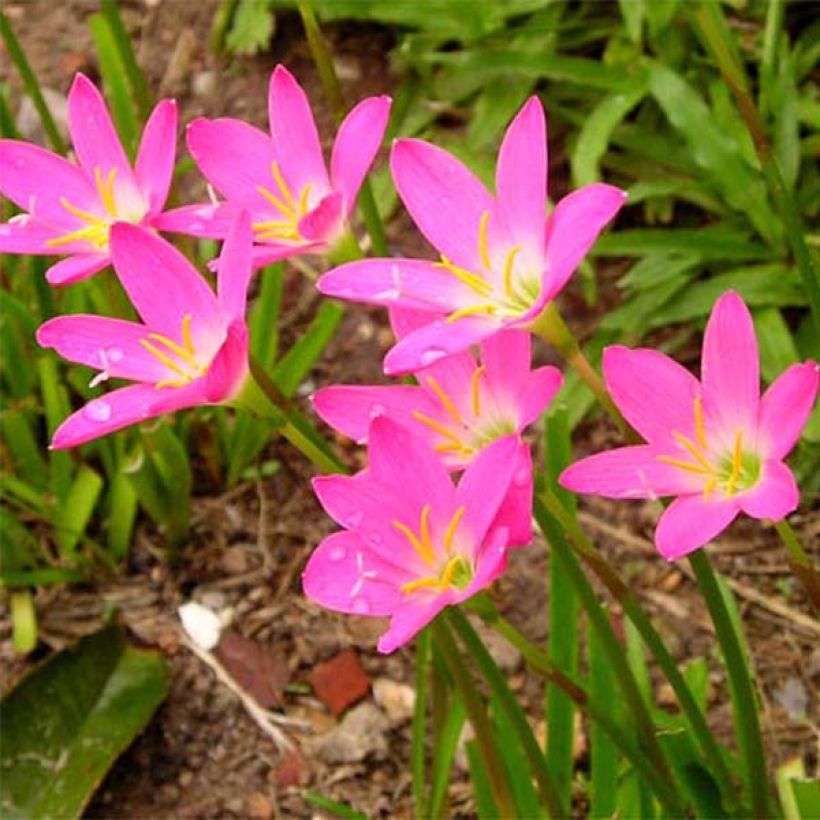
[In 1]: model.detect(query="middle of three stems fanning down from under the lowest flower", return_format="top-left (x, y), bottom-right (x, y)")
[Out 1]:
top-left (445, 607), bottom-right (569, 818)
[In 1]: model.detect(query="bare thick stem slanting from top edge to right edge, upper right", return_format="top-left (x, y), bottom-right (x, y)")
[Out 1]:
top-left (689, 0), bottom-right (820, 351)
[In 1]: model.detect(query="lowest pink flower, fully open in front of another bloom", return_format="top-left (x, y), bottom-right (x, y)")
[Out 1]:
top-left (302, 418), bottom-right (518, 652)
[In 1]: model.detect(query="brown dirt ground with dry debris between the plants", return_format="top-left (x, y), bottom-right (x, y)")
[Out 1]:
top-left (0, 0), bottom-right (820, 818)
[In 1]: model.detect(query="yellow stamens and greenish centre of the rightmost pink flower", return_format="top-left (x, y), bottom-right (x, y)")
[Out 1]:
top-left (657, 396), bottom-right (760, 501)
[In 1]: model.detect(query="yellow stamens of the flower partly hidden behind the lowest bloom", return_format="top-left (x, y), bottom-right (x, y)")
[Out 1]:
top-left (413, 365), bottom-right (516, 458)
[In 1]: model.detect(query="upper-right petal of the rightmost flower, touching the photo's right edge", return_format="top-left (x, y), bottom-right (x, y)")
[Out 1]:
top-left (757, 362), bottom-right (820, 459)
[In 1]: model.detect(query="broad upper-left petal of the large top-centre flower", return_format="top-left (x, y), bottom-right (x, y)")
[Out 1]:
top-left (390, 139), bottom-right (493, 270)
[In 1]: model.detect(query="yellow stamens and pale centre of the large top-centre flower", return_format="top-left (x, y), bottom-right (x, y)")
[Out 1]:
top-left (437, 211), bottom-right (541, 322)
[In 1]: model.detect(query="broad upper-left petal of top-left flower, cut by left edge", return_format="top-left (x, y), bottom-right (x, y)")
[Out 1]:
top-left (0, 140), bottom-right (101, 224)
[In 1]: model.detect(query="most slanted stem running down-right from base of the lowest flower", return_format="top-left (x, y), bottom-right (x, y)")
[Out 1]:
top-left (469, 595), bottom-right (686, 817)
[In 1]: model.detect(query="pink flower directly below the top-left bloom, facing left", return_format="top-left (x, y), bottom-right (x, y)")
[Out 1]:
top-left (37, 214), bottom-right (252, 449)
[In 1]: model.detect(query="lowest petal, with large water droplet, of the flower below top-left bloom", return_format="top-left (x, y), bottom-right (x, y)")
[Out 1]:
top-left (51, 384), bottom-right (167, 450)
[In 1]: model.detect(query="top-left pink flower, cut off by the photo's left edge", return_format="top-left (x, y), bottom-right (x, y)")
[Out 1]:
top-left (0, 74), bottom-right (177, 285)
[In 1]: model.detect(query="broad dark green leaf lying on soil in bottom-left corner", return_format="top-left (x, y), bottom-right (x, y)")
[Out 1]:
top-left (0, 627), bottom-right (167, 818)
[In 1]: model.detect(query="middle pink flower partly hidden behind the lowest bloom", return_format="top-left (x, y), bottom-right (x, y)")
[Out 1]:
top-left (313, 322), bottom-right (562, 546)
